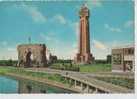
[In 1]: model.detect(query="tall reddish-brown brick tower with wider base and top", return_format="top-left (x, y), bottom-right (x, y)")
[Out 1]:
top-left (75, 4), bottom-right (93, 64)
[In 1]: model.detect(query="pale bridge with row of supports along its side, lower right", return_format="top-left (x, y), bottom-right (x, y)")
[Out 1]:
top-left (62, 74), bottom-right (133, 93)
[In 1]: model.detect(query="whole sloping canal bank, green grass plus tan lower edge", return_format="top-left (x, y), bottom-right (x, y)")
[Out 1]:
top-left (0, 67), bottom-right (81, 93)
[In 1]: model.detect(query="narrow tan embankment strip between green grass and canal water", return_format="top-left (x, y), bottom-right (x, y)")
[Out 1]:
top-left (5, 73), bottom-right (81, 93)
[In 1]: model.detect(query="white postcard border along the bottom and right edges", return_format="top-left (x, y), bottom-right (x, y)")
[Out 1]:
top-left (0, 0), bottom-right (137, 99)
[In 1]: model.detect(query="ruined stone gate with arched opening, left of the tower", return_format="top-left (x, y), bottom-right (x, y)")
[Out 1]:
top-left (17, 44), bottom-right (47, 67)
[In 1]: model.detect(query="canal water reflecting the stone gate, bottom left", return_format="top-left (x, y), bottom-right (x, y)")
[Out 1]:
top-left (0, 76), bottom-right (74, 93)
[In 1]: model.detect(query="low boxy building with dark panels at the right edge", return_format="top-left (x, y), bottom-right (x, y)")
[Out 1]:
top-left (112, 46), bottom-right (135, 72)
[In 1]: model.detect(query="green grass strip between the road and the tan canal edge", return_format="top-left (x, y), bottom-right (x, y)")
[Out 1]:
top-left (0, 66), bottom-right (68, 85)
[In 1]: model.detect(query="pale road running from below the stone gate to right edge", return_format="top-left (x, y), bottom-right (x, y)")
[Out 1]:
top-left (27, 68), bottom-right (134, 79)
